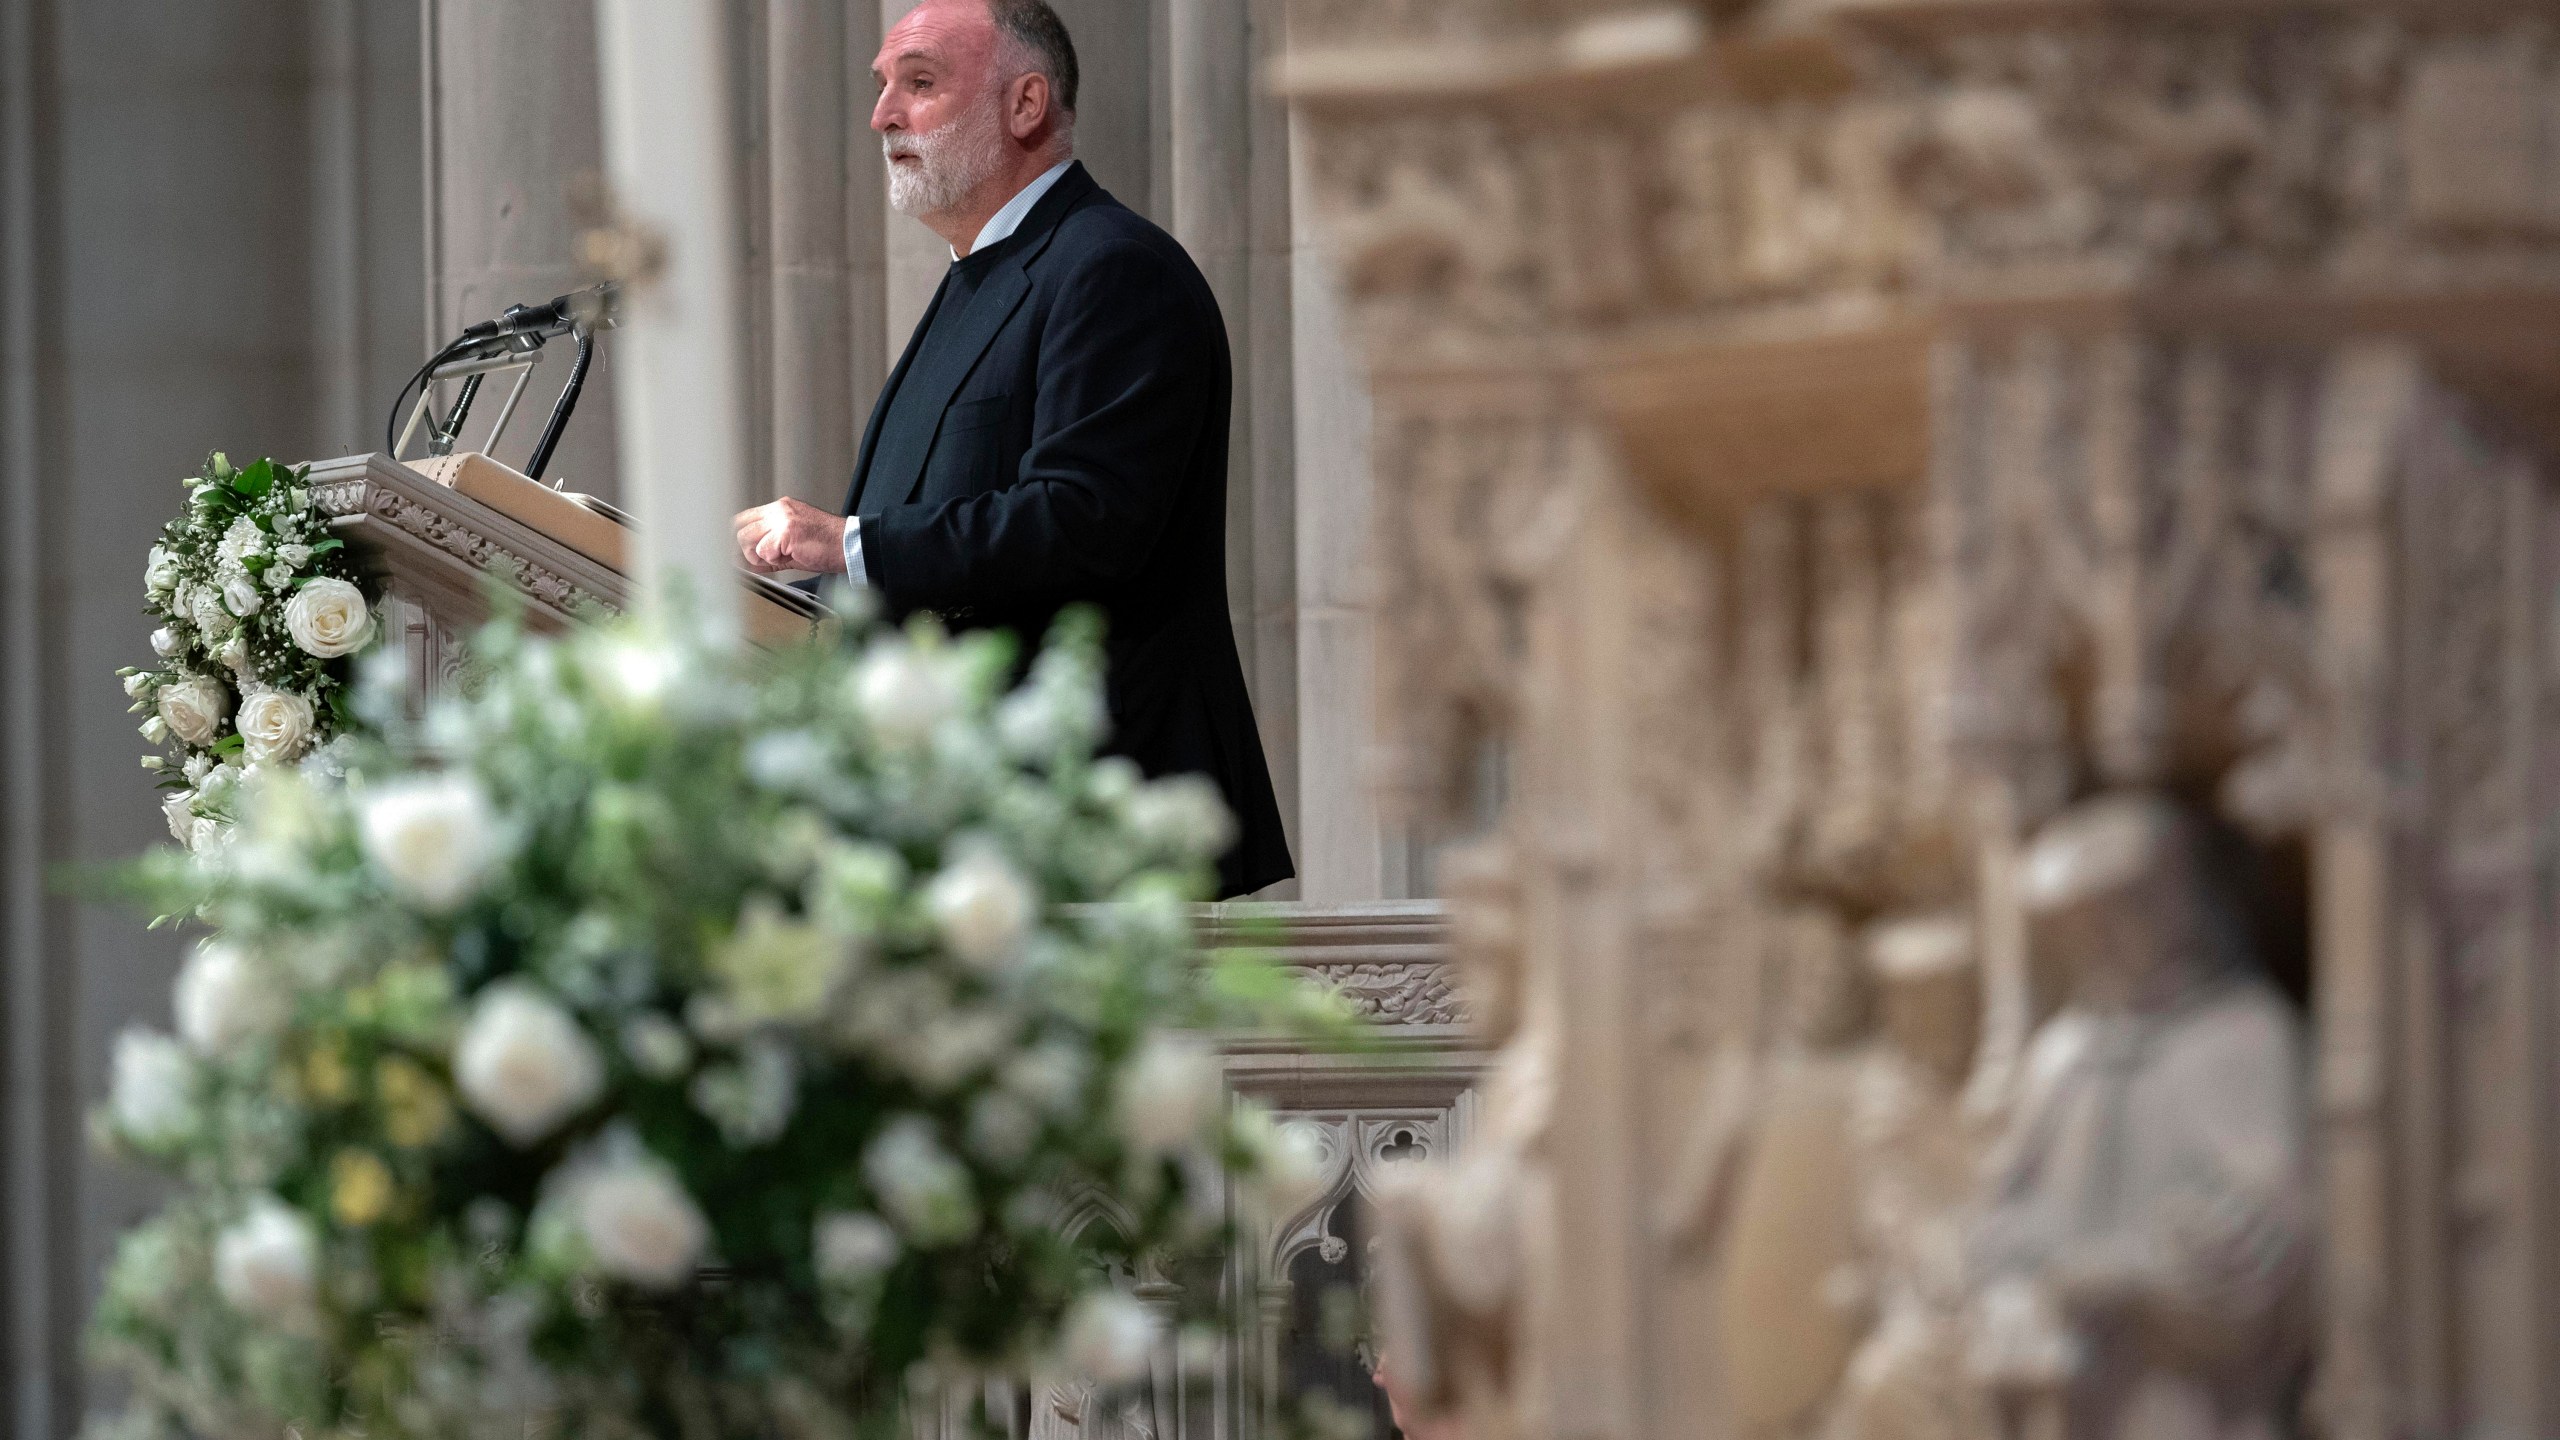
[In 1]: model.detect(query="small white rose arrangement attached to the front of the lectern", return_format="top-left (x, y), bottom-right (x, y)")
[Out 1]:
top-left (118, 454), bottom-right (376, 846)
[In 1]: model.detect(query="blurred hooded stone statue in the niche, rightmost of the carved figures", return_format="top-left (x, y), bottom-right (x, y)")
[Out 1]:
top-left (1969, 792), bottom-right (2312, 1440)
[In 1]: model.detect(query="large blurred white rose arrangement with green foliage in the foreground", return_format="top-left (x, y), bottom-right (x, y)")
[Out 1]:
top-left (97, 602), bottom-right (1347, 1440)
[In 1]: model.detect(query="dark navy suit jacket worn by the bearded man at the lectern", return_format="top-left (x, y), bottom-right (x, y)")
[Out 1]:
top-left (845, 164), bottom-right (1293, 894)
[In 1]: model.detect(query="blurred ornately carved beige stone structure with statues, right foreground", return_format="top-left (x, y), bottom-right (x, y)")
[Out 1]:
top-left (1277, 0), bottom-right (2560, 1440)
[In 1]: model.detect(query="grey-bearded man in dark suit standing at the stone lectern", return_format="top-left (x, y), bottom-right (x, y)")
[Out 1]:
top-left (737, 0), bottom-right (1293, 894)
